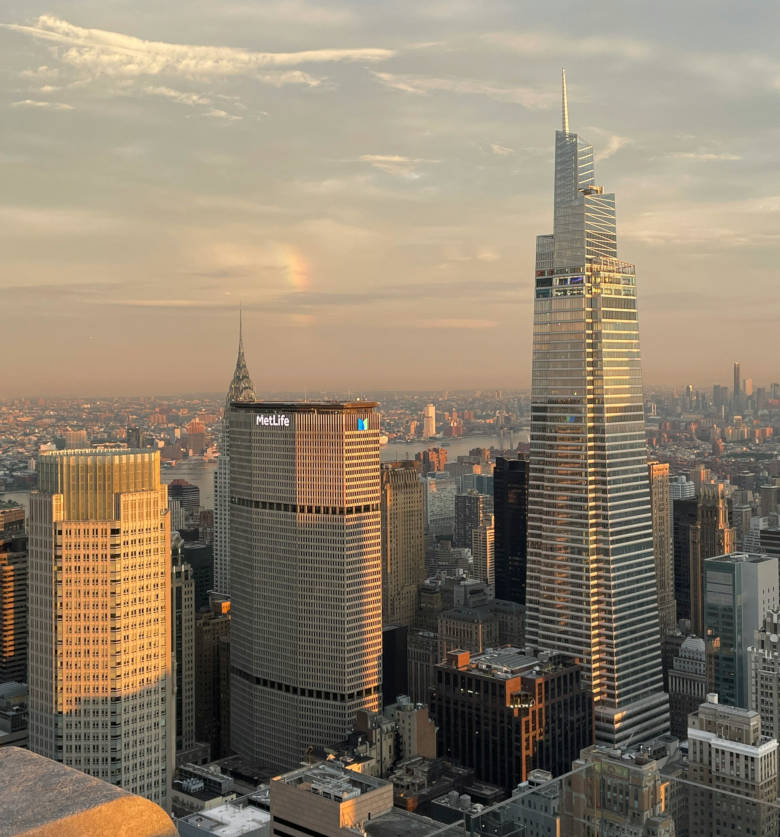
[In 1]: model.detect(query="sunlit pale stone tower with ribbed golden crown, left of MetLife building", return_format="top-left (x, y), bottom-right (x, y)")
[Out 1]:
top-left (29, 450), bottom-right (174, 808)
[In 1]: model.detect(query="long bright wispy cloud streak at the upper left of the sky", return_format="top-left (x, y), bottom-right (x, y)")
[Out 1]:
top-left (0, 15), bottom-right (395, 83)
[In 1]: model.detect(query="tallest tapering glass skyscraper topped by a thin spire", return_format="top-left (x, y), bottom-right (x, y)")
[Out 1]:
top-left (526, 74), bottom-right (669, 746)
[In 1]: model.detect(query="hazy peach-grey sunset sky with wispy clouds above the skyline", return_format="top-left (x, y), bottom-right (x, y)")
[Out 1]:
top-left (0, 0), bottom-right (780, 398)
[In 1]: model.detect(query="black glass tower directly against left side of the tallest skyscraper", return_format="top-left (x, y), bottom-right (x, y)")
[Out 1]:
top-left (493, 456), bottom-right (528, 604)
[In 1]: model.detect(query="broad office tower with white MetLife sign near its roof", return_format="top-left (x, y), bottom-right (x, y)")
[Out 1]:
top-left (230, 402), bottom-right (382, 769)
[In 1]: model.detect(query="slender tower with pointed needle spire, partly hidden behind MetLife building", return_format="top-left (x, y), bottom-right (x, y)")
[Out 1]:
top-left (214, 312), bottom-right (255, 596)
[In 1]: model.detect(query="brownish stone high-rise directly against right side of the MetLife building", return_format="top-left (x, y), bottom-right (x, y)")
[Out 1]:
top-left (381, 461), bottom-right (425, 627)
